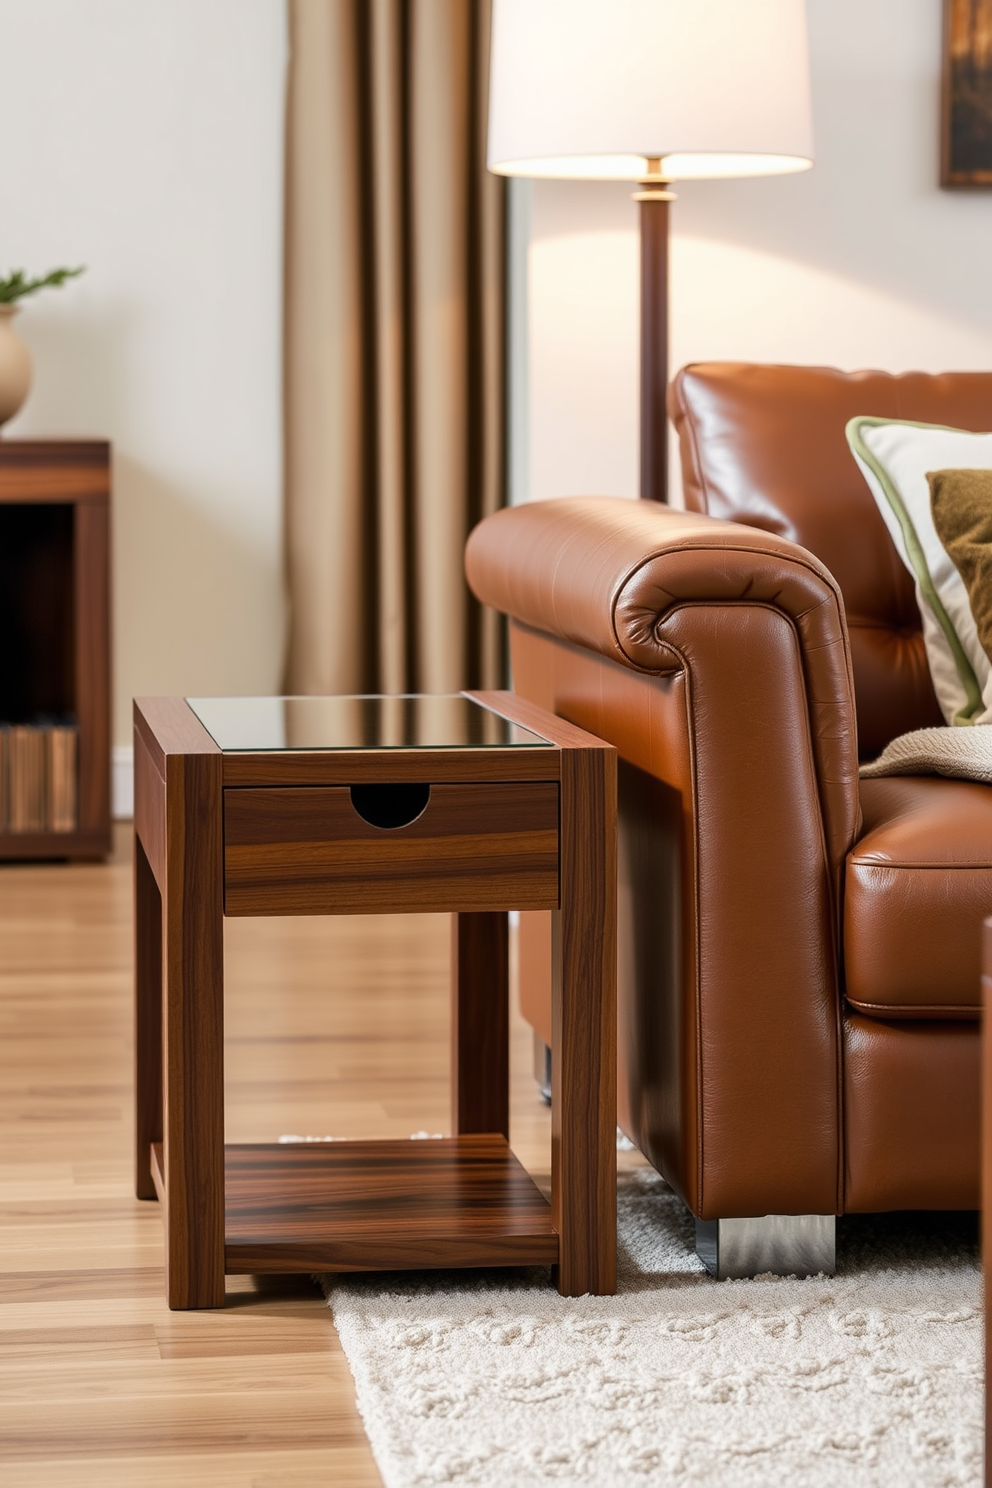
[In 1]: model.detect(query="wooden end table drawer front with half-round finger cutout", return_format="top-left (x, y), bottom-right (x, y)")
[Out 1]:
top-left (225, 781), bottom-right (558, 915)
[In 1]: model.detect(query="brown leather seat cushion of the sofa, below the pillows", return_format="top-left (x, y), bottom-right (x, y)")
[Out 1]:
top-left (843, 775), bottom-right (992, 1019)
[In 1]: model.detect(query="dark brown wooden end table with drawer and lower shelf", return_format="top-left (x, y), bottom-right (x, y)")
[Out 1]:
top-left (134, 692), bottom-right (616, 1308)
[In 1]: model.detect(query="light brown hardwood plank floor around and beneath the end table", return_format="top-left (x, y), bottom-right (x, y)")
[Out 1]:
top-left (0, 829), bottom-right (574, 1488)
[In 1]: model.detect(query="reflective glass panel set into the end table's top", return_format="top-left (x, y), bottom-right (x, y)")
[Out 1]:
top-left (186, 693), bottom-right (552, 753)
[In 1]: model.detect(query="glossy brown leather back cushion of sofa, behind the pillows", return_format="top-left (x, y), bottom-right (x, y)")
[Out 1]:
top-left (668, 362), bottom-right (992, 759)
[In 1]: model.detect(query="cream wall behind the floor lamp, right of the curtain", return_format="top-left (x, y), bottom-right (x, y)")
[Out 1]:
top-left (512, 0), bottom-right (992, 500)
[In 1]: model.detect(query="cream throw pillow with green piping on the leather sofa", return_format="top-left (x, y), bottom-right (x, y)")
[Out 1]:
top-left (846, 409), bottom-right (992, 723)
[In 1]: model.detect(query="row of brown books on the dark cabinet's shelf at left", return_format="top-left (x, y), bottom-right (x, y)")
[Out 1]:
top-left (0, 719), bottom-right (79, 833)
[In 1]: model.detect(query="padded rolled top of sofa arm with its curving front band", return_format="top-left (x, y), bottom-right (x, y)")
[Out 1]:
top-left (466, 496), bottom-right (858, 862)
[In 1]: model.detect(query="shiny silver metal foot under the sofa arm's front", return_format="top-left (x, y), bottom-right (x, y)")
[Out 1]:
top-left (696, 1214), bottom-right (837, 1281)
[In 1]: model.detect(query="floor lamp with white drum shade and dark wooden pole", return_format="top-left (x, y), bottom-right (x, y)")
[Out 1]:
top-left (488, 0), bottom-right (812, 501)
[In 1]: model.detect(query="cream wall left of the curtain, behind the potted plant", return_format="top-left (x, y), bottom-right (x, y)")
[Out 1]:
top-left (0, 0), bottom-right (286, 745)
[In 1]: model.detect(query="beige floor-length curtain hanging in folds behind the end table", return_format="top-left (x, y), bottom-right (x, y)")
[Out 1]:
top-left (284, 0), bottom-right (504, 692)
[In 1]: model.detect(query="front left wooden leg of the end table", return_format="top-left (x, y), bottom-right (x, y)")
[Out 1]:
top-left (164, 754), bottom-right (225, 1308)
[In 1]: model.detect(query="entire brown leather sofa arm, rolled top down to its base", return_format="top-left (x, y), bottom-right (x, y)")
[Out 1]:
top-left (466, 497), bottom-right (860, 1219)
